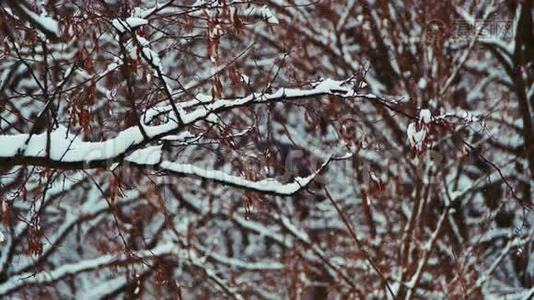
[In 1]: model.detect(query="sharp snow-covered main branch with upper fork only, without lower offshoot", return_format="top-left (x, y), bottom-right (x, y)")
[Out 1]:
top-left (0, 79), bottom-right (369, 169)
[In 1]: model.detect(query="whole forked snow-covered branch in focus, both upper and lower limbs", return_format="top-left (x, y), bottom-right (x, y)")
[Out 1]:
top-left (0, 79), bottom-right (368, 196)
